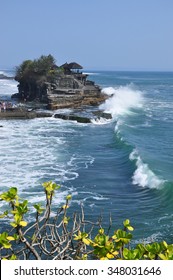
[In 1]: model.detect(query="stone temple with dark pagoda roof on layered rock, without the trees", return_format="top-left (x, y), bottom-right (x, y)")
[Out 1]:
top-left (42, 62), bottom-right (105, 109)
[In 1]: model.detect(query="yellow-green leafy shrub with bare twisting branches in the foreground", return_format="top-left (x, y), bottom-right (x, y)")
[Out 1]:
top-left (0, 181), bottom-right (173, 260)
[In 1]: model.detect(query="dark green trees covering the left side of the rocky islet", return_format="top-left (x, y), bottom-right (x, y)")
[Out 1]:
top-left (15, 54), bottom-right (63, 101)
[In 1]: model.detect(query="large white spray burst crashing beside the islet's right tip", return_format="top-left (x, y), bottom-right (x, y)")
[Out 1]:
top-left (100, 84), bottom-right (143, 118)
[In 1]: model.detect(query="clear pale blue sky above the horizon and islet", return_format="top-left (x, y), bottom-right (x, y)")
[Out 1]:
top-left (0, 0), bottom-right (173, 71)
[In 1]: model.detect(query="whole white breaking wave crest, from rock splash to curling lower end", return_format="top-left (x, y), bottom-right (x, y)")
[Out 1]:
top-left (100, 84), bottom-right (165, 189)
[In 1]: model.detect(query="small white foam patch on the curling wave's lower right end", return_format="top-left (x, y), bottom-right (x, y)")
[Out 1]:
top-left (129, 149), bottom-right (165, 189)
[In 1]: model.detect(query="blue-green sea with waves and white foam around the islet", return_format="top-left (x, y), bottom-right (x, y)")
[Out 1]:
top-left (0, 70), bottom-right (173, 243)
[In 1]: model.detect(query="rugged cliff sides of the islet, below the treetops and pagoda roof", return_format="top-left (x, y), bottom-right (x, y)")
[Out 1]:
top-left (14, 74), bottom-right (106, 109)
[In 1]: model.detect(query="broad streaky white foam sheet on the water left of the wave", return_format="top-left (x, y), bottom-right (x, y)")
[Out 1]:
top-left (0, 118), bottom-right (94, 197)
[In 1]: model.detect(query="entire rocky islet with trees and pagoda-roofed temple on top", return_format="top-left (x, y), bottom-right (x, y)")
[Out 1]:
top-left (12, 55), bottom-right (107, 110)
